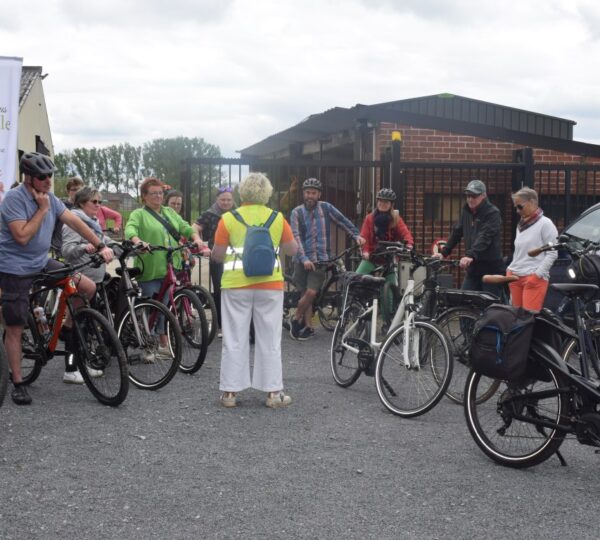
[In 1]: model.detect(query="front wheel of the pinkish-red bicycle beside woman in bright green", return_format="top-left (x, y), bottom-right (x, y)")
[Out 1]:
top-left (172, 289), bottom-right (208, 373)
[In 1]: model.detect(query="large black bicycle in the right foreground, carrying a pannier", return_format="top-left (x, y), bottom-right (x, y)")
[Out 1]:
top-left (464, 238), bottom-right (600, 468)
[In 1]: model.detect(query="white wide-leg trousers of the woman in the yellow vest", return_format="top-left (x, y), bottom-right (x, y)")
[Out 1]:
top-left (219, 289), bottom-right (283, 392)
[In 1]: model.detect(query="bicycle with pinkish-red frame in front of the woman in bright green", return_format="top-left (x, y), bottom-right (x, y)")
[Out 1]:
top-left (142, 242), bottom-right (208, 374)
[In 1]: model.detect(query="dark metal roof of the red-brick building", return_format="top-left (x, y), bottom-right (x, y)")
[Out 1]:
top-left (240, 94), bottom-right (600, 157)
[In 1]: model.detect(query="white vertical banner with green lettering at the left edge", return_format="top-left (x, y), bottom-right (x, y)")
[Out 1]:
top-left (0, 56), bottom-right (23, 190)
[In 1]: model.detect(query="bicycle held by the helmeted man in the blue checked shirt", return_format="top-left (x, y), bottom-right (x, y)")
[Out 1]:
top-left (283, 246), bottom-right (359, 332)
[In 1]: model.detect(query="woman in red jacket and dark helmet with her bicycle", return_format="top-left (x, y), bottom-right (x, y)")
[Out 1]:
top-left (356, 188), bottom-right (415, 283)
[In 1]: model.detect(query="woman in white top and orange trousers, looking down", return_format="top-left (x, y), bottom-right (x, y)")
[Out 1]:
top-left (506, 187), bottom-right (558, 311)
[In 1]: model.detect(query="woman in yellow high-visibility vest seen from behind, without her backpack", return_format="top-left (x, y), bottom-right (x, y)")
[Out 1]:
top-left (211, 173), bottom-right (298, 408)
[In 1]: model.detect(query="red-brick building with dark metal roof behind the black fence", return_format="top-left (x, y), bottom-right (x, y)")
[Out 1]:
top-left (240, 94), bottom-right (600, 258)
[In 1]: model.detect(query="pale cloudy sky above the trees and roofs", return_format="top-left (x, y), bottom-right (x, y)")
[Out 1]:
top-left (0, 0), bottom-right (600, 157)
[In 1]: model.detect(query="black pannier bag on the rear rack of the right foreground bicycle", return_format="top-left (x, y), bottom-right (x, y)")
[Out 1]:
top-left (469, 304), bottom-right (535, 381)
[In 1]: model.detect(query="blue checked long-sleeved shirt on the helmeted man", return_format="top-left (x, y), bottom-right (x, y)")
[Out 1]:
top-left (290, 201), bottom-right (359, 263)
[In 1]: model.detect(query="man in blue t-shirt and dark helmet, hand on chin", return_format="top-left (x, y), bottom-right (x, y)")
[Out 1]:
top-left (0, 152), bottom-right (113, 405)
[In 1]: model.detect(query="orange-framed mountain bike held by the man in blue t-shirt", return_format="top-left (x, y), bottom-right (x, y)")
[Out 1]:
top-left (22, 258), bottom-right (129, 406)
